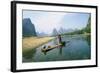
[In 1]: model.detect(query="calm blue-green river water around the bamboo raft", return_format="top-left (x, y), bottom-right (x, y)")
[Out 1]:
top-left (23, 35), bottom-right (91, 62)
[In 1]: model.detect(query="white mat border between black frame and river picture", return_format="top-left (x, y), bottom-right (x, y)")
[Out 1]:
top-left (16, 4), bottom-right (96, 70)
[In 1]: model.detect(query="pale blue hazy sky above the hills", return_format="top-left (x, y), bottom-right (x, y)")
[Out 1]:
top-left (23, 10), bottom-right (90, 34)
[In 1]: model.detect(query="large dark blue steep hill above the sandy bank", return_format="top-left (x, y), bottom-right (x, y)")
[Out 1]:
top-left (22, 18), bottom-right (36, 37)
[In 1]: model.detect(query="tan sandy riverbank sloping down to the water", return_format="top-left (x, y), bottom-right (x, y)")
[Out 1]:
top-left (22, 37), bottom-right (55, 52)
